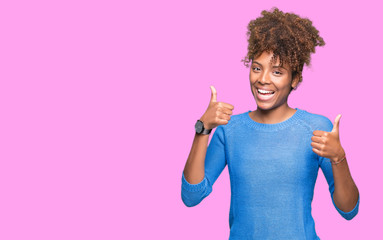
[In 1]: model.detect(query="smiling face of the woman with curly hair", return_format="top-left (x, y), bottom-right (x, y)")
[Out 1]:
top-left (250, 51), bottom-right (298, 110)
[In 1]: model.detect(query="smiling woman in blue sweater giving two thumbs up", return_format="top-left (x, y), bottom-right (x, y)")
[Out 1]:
top-left (181, 8), bottom-right (359, 240)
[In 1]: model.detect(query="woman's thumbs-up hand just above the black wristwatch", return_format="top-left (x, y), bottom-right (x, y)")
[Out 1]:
top-left (200, 86), bottom-right (234, 129)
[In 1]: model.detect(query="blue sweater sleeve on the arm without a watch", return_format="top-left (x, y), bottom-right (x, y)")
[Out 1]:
top-left (316, 118), bottom-right (360, 220)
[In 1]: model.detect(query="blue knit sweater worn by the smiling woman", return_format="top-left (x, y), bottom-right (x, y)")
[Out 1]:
top-left (181, 108), bottom-right (360, 240)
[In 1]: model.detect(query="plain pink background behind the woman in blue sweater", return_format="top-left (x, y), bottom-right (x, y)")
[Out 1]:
top-left (0, 0), bottom-right (383, 240)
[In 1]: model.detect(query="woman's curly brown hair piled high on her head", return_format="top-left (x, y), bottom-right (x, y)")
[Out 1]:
top-left (241, 7), bottom-right (325, 91)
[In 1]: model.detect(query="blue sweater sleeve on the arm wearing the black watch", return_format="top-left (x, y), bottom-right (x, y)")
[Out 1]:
top-left (181, 125), bottom-right (227, 207)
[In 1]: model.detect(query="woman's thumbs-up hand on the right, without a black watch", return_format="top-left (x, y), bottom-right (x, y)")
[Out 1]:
top-left (311, 114), bottom-right (345, 161)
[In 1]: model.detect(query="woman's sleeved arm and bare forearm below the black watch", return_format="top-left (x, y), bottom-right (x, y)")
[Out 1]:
top-left (181, 126), bottom-right (226, 207)
